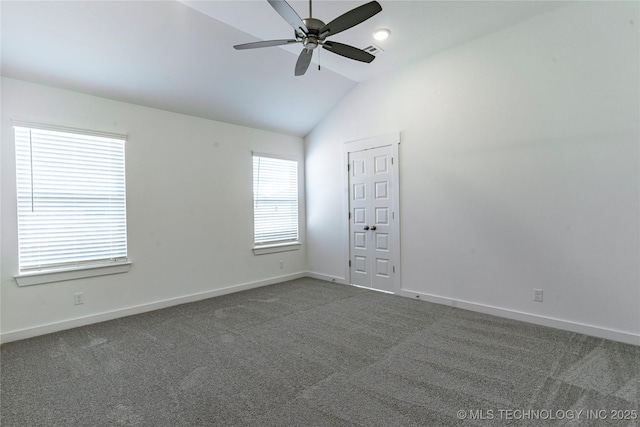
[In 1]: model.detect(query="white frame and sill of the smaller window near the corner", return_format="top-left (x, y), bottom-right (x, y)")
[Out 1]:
top-left (251, 151), bottom-right (302, 255)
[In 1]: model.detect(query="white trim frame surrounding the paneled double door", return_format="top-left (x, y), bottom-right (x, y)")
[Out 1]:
top-left (342, 132), bottom-right (402, 294)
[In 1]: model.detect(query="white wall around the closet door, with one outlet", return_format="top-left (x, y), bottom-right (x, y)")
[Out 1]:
top-left (306, 2), bottom-right (640, 343)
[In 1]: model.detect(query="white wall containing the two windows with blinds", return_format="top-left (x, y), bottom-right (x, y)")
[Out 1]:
top-left (0, 78), bottom-right (306, 341)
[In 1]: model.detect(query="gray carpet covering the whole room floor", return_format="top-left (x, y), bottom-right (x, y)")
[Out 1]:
top-left (0, 279), bottom-right (640, 427)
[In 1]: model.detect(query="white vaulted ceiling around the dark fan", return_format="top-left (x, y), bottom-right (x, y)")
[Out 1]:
top-left (0, 0), bottom-right (562, 136)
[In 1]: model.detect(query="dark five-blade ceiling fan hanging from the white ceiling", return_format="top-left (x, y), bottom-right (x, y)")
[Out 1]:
top-left (234, 0), bottom-right (382, 76)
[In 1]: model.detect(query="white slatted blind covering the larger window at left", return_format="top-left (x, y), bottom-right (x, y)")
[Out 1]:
top-left (14, 126), bottom-right (127, 273)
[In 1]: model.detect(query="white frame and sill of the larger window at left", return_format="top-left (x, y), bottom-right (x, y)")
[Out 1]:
top-left (11, 120), bottom-right (131, 286)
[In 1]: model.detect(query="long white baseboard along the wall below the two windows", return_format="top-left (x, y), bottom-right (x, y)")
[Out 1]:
top-left (0, 272), bottom-right (307, 344)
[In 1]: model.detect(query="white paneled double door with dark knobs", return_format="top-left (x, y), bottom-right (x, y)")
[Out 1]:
top-left (348, 146), bottom-right (398, 292)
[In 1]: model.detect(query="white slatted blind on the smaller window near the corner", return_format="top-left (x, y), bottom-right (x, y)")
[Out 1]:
top-left (253, 154), bottom-right (298, 246)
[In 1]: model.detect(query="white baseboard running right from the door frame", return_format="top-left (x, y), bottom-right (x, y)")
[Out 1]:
top-left (398, 289), bottom-right (640, 345)
